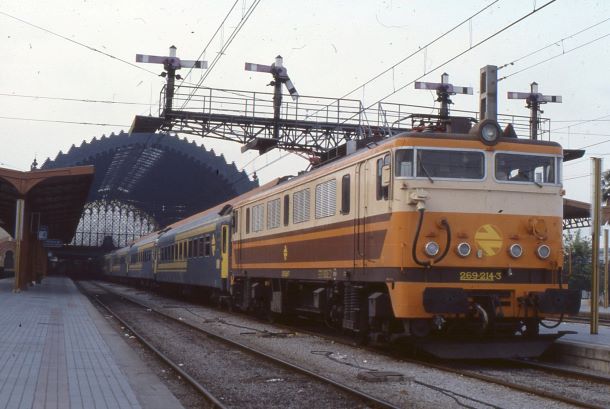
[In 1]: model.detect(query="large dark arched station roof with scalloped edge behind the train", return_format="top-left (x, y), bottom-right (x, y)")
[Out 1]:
top-left (42, 132), bottom-right (258, 227)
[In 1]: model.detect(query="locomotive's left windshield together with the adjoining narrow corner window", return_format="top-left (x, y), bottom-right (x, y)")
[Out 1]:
top-left (395, 149), bottom-right (485, 180)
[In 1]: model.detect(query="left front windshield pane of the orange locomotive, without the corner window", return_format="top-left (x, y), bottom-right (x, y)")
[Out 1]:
top-left (416, 149), bottom-right (485, 180)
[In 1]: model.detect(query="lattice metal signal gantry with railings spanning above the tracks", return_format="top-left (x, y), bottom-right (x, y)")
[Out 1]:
top-left (131, 85), bottom-right (550, 157)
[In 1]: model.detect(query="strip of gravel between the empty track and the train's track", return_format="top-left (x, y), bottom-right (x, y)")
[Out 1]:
top-left (95, 284), bottom-right (571, 409)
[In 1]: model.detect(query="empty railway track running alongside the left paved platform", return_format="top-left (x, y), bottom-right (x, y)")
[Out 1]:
top-left (79, 284), bottom-right (398, 409)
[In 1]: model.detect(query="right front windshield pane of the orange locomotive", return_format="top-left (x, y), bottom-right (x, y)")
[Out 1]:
top-left (495, 153), bottom-right (558, 184)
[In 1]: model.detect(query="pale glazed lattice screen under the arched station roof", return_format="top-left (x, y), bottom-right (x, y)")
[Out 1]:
top-left (70, 200), bottom-right (158, 247)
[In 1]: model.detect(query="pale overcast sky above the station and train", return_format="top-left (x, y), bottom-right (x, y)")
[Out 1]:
top-left (0, 0), bottom-right (610, 201)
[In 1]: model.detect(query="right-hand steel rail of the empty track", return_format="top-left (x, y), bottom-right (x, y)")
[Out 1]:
top-left (86, 283), bottom-right (401, 409)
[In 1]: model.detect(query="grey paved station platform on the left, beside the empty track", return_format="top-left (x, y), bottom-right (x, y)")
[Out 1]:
top-left (0, 277), bottom-right (182, 409)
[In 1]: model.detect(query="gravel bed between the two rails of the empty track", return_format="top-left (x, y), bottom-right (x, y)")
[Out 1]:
top-left (92, 286), bottom-right (366, 408)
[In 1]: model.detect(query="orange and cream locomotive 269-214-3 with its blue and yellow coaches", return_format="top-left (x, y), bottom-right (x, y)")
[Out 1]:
top-left (105, 107), bottom-right (580, 358)
